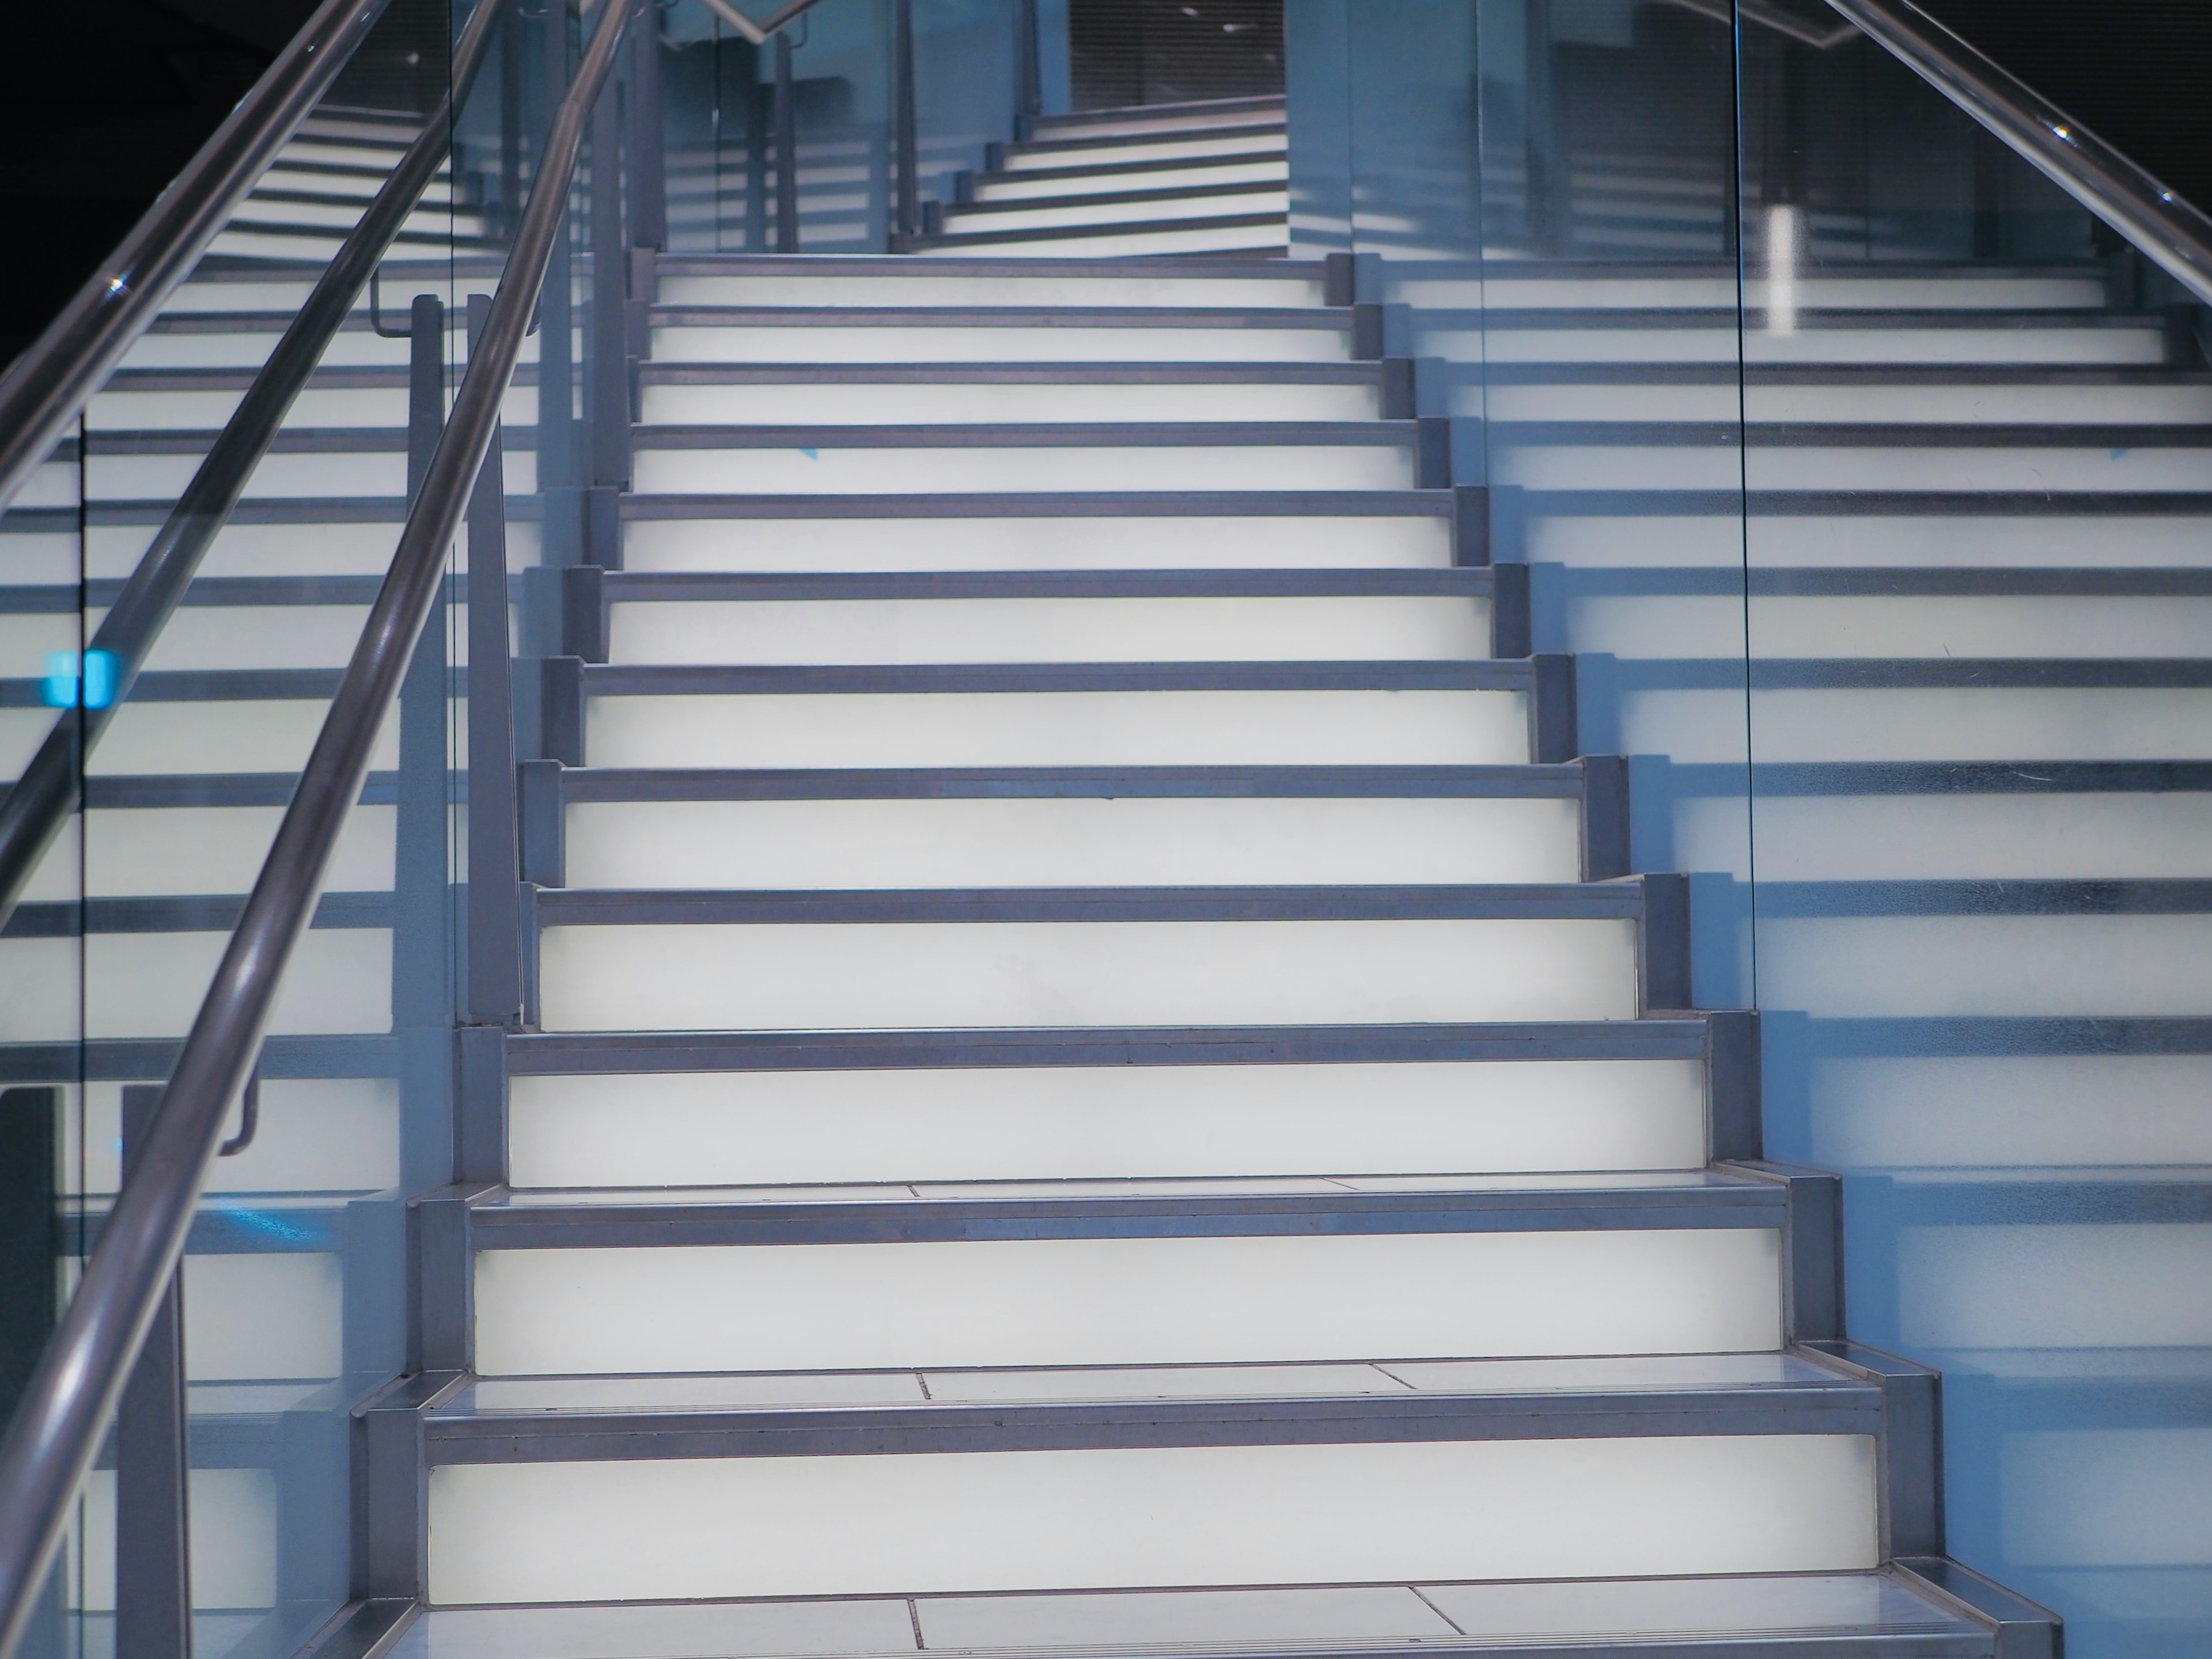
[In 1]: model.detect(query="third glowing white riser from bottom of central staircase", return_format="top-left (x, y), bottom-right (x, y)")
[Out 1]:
top-left (506, 1059), bottom-right (1706, 1188)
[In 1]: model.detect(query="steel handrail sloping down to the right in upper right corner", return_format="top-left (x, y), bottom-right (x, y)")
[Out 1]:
top-left (1827, 0), bottom-right (2212, 305)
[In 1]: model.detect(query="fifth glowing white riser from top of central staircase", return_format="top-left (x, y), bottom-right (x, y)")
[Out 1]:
top-left (619, 516), bottom-right (1451, 571)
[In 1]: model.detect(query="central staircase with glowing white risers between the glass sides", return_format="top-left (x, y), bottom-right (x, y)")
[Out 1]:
top-left (340, 111), bottom-right (2041, 1657)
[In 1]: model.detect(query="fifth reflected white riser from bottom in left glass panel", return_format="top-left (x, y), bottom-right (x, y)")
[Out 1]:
top-left (24, 805), bottom-right (396, 903)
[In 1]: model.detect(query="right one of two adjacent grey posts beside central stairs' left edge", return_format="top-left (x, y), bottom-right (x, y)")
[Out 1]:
top-left (467, 294), bottom-right (522, 1027)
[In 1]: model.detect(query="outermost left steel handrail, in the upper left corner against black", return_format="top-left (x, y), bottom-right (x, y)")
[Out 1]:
top-left (0, 0), bottom-right (387, 520)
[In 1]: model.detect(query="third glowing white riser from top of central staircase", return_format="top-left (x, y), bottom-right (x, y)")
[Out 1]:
top-left (643, 380), bottom-right (1382, 427)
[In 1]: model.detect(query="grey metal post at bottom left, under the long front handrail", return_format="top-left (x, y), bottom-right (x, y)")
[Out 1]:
top-left (115, 1084), bottom-right (192, 1659)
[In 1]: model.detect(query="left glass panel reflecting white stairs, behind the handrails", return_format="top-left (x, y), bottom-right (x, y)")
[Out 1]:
top-left (0, 2), bottom-right (584, 1659)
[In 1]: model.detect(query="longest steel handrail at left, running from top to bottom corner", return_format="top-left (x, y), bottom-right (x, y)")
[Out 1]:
top-left (0, 5), bottom-right (630, 1654)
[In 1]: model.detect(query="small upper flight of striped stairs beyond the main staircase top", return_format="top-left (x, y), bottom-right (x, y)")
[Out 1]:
top-left (911, 97), bottom-right (1290, 259)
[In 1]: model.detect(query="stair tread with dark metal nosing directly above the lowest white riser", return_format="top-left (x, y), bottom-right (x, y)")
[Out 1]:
top-left (425, 1351), bottom-right (1883, 1464)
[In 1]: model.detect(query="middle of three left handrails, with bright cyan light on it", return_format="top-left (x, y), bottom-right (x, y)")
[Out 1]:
top-left (0, 0), bottom-right (500, 942)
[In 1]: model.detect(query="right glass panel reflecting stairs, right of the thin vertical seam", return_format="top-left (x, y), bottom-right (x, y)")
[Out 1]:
top-left (1741, 20), bottom-right (2212, 1659)
